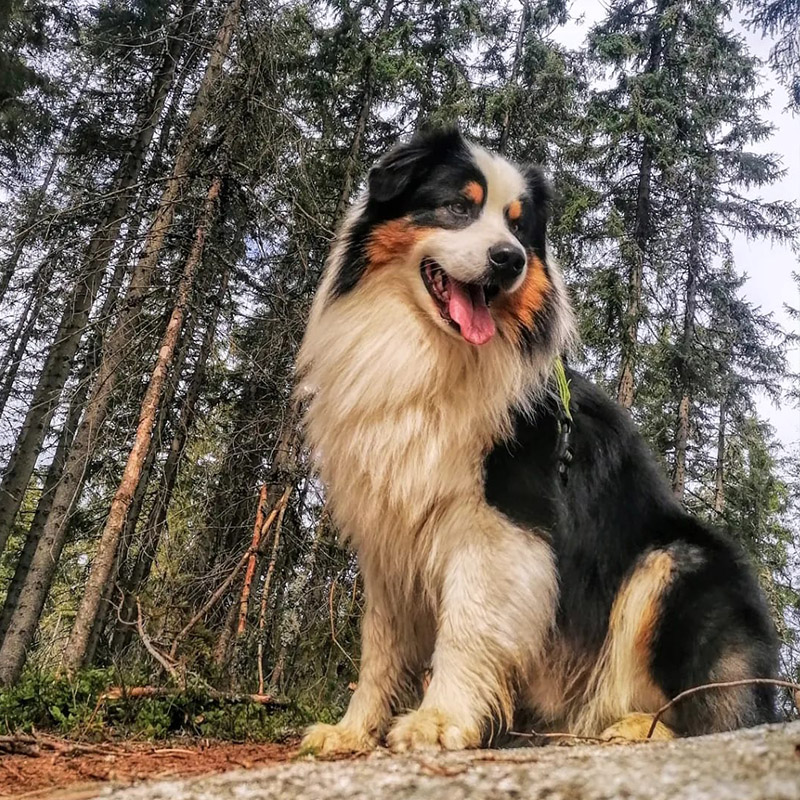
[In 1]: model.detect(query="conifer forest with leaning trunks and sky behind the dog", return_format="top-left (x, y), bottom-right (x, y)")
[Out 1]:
top-left (0, 0), bottom-right (800, 736)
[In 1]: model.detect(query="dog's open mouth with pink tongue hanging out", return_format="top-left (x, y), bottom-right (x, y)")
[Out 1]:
top-left (420, 258), bottom-right (498, 344)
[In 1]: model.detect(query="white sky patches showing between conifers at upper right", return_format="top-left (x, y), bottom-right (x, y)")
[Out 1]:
top-left (553, 0), bottom-right (800, 445)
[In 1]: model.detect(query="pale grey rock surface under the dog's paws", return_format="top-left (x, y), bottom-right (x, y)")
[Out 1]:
top-left (97, 722), bottom-right (800, 800)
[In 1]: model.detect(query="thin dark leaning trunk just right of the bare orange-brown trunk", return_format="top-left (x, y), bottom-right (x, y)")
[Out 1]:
top-left (111, 268), bottom-right (229, 653)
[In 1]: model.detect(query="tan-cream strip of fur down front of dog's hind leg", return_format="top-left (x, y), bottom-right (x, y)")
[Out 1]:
top-left (570, 550), bottom-right (674, 736)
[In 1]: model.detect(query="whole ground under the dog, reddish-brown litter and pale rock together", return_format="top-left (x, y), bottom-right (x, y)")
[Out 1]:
top-left (0, 722), bottom-right (800, 800)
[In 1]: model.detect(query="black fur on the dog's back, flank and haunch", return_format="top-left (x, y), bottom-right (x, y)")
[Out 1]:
top-left (485, 371), bottom-right (777, 734)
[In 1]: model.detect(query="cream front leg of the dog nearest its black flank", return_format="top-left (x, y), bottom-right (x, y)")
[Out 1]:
top-left (387, 523), bottom-right (557, 752)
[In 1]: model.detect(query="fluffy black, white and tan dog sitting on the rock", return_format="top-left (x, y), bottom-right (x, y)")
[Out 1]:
top-left (297, 129), bottom-right (777, 753)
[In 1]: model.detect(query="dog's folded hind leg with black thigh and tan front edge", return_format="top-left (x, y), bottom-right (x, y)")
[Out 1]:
top-left (571, 536), bottom-right (775, 739)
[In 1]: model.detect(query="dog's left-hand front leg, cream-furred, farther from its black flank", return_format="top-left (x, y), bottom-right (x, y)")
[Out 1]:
top-left (301, 581), bottom-right (421, 754)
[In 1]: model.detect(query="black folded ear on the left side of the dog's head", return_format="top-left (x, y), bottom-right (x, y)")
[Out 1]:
top-left (368, 128), bottom-right (465, 203)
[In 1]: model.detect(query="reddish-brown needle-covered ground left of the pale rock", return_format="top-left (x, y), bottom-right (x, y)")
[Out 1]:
top-left (0, 737), bottom-right (299, 800)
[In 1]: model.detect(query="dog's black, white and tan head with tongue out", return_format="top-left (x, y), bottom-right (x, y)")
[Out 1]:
top-left (327, 130), bottom-right (563, 354)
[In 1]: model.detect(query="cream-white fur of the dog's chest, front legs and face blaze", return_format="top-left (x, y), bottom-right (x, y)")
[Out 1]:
top-left (298, 142), bottom-right (572, 752)
